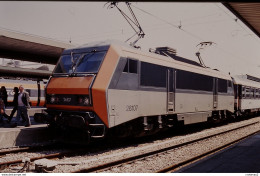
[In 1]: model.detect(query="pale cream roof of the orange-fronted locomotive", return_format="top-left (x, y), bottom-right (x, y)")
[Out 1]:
top-left (63, 40), bottom-right (231, 80)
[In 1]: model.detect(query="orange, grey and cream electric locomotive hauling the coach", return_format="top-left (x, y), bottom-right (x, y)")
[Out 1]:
top-left (46, 41), bottom-right (234, 140)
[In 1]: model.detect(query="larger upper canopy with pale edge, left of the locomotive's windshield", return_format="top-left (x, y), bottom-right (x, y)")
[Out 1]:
top-left (0, 29), bottom-right (74, 64)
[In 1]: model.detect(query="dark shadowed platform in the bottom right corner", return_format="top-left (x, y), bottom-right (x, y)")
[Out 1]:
top-left (176, 133), bottom-right (260, 173)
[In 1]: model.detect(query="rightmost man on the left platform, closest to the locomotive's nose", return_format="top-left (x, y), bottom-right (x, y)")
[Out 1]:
top-left (13, 85), bottom-right (31, 127)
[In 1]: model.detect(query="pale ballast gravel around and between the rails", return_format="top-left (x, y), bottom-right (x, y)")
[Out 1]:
top-left (0, 117), bottom-right (260, 173)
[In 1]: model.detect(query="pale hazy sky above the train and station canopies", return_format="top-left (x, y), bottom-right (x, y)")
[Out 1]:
top-left (0, 1), bottom-right (260, 77)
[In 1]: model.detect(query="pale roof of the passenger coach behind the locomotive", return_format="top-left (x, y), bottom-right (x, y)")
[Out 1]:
top-left (232, 75), bottom-right (260, 88)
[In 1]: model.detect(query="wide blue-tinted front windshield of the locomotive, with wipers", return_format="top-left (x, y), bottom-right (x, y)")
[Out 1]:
top-left (53, 52), bottom-right (106, 74)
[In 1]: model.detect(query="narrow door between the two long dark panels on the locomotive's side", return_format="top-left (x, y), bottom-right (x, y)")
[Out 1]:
top-left (167, 69), bottom-right (175, 113)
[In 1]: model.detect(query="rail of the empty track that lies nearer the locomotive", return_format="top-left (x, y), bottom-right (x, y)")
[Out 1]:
top-left (72, 122), bottom-right (259, 173)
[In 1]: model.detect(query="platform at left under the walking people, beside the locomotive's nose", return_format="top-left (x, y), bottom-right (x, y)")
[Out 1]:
top-left (0, 107), bottom-right (50, 149)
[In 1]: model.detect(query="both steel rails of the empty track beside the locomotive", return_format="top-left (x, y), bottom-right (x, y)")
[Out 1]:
top-left (74, 122), bottom-right (260, 173)
